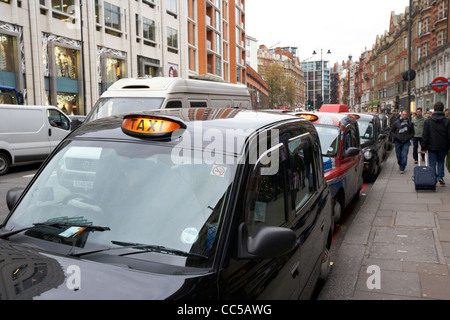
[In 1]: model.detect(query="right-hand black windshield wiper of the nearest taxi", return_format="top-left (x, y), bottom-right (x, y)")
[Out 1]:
top-left (70, 241), bottom-right (208, 259)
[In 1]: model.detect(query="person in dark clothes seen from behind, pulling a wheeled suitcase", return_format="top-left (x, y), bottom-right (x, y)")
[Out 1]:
top-left (422, 102), bottom-right (450, 185)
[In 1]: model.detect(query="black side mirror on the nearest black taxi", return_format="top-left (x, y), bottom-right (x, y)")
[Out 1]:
top-left (237, 223), bottom-right (297, 260)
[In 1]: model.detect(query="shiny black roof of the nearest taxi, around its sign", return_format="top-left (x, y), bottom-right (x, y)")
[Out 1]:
top-left (68, 108), bottom-right (311, 153)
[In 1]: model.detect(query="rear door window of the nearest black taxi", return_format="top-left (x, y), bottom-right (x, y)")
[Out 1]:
top-left (288, 135), bottom-right (317, 211)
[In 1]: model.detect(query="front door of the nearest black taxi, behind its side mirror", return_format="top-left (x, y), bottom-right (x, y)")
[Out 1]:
top-left (219, 141), bottom-right (300, 300)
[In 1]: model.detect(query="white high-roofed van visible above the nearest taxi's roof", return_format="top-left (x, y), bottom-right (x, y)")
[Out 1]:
top-left (85, 77), bottom-right (252, 122)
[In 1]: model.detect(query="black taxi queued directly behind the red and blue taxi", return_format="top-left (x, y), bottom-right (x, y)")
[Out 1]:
top-left (351, 113), bottom-right (387, 181)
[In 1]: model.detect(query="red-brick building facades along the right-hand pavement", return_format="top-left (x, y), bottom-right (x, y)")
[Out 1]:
top-left (346, 0), bottom-right (450, 113)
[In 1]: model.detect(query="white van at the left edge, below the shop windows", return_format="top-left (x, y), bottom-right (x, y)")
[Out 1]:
top-left (0, 104), bottom-right (71, 175)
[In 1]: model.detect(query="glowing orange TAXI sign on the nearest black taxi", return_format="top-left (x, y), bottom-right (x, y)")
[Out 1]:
top-left (122, 115), bottom-right (186, 138)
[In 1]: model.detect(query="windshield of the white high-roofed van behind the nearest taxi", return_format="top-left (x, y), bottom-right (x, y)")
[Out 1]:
top-left (85, 97), bottom-right (164, 123)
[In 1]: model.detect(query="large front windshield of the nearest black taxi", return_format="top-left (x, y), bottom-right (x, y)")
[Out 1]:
top-left (5, 141), bottom-right (237, 267)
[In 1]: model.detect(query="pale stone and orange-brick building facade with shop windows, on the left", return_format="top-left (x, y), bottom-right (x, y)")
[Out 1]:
top-left (0, 0), bottom-right (246, 115)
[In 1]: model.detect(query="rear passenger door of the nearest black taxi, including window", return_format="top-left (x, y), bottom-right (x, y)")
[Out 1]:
top-left (288, 133), bottom-right (332, 299)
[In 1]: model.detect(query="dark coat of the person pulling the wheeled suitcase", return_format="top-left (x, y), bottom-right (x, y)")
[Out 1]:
top-left (422, 111), bottom-right (450, 151)
